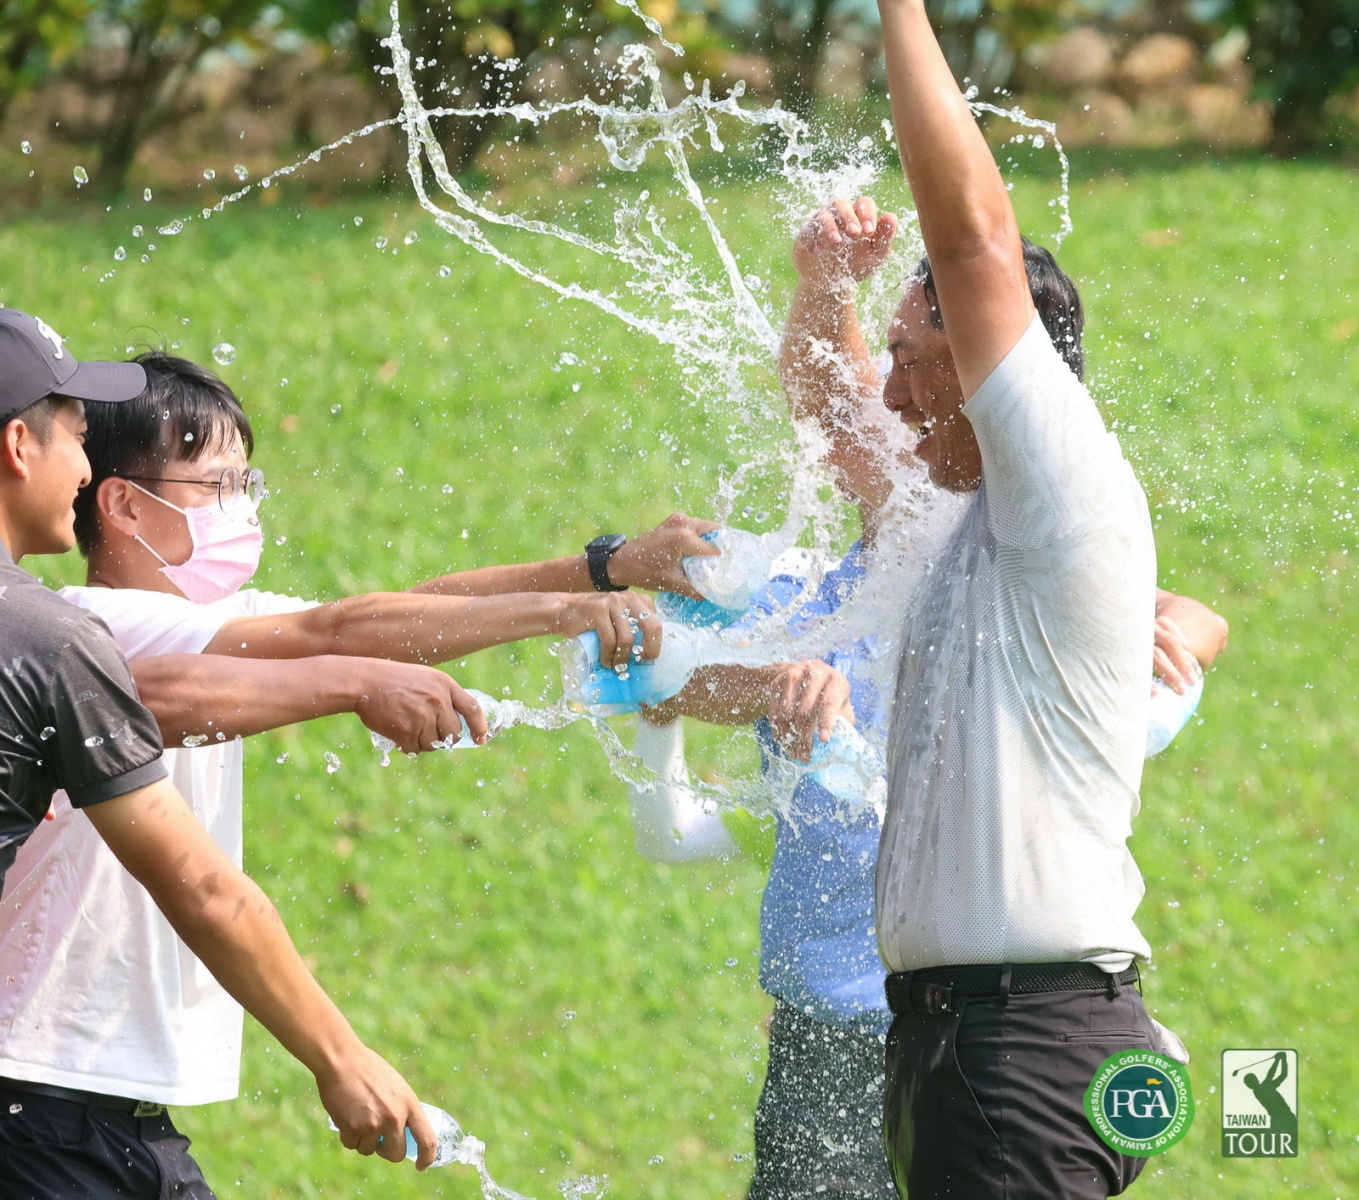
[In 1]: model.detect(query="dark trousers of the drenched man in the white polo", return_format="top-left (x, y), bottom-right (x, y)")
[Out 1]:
top-left (883, 987), bottom-right (1162, 1200)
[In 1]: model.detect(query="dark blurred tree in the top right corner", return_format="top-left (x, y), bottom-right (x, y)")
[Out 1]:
top-left (1230, 0), bottom-right (1359, 155)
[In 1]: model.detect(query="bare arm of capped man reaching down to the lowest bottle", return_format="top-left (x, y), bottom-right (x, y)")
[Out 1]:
top-left (84, 780), bottom-right (435, 1169)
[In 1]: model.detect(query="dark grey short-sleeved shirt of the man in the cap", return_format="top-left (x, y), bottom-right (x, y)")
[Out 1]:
top-left (0, 542), bottom-right (166, 887)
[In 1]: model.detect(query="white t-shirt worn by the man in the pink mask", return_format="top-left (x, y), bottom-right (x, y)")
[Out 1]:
top-left (0, 587), bottom-right (311, 1105)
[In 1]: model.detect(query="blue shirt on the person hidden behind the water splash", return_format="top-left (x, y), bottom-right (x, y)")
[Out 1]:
top-left (741, 542), bottom-right (892, 1033)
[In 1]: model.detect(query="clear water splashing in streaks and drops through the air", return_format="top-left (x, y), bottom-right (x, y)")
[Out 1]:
top-left (98, 14), bottom-right (1071, 1200)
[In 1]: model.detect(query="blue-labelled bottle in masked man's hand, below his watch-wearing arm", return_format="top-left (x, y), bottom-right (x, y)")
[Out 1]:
top-left (559, 621), bottom-right (716, 716)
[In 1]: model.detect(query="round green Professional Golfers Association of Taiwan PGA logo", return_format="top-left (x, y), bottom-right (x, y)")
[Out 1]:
top-left (1086, 1051), bottom-right (1193, 1158)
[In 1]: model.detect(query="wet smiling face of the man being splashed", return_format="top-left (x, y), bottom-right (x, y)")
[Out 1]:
top-left (882, 283), bottom-right (981, 492)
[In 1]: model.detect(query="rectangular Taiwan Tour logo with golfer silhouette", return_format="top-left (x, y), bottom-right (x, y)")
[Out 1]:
top-left (1222, 1051), bottom-right (1298, 1158)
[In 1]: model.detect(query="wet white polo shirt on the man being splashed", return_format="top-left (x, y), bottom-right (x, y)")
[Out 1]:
top-left (877, 317), bottom-right (1157, 970)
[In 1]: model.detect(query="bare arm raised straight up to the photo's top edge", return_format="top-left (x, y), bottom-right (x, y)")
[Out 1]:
top-left (878, 0), bottom-right (1034, 397)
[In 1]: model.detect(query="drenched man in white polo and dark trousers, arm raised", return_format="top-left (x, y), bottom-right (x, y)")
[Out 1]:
top-left (877, 0), bottom-right (1179, 1200)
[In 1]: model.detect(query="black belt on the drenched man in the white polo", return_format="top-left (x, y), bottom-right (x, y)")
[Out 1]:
top-left (887, 962), bottom-right (1142, 1017)
